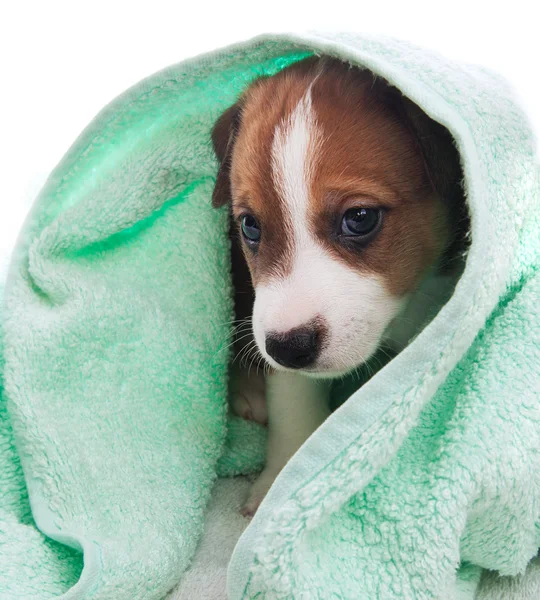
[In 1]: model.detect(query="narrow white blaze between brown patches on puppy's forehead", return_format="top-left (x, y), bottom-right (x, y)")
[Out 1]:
top-left (272, 84), bottom-right (321, 246)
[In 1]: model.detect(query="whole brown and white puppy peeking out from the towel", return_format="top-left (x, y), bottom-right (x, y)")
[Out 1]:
top-left (212, 57), bottom-right (465, 516)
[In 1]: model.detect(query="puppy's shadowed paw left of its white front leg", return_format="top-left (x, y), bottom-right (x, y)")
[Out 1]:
top-left (229, 371), bottom-right (268, 425)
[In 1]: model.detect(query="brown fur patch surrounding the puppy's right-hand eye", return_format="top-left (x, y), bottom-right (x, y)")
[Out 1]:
top-left (304, 61), bottom-right (447, 296)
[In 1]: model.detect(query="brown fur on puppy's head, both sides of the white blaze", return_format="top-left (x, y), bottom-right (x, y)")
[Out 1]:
top-left (214, 58), bottom-right (461, 296)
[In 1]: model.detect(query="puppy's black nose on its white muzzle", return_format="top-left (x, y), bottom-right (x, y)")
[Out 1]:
top-left (266, 326), bottom-right (321, 369)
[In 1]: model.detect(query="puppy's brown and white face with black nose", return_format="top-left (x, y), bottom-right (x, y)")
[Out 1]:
top-left (213, 59), bottom-right (458, 376)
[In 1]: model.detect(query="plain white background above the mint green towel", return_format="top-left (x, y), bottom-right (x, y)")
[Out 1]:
top-left (0, 0), bottom-right (540, 270)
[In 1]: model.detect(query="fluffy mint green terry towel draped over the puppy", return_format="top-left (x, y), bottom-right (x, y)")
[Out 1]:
top-left (0, 34), bottom-right (540, 600)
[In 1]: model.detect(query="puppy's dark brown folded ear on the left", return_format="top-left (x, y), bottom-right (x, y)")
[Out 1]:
top-left (212, 102), bottom-right (241, 208)
